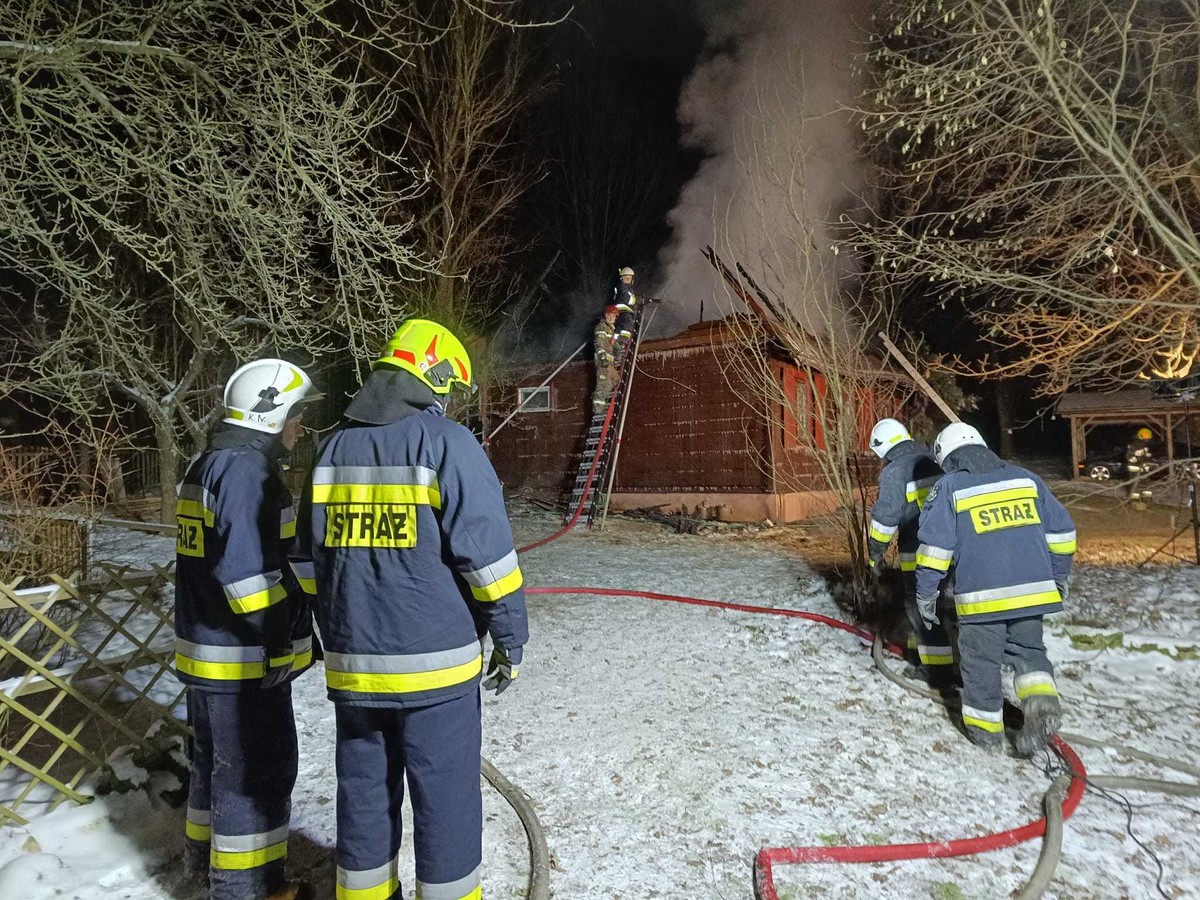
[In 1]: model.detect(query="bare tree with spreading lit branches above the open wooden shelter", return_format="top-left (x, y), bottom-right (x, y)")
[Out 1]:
top-left (858, 0), bottom-right (1200, 395)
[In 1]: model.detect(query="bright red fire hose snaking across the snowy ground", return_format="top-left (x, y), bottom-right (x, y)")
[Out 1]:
top-left (526, 585), bottom-right (1087, 900)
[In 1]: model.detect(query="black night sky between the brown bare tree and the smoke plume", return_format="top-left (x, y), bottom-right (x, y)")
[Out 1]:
top-left (522, 0), bottom-right (704, 355)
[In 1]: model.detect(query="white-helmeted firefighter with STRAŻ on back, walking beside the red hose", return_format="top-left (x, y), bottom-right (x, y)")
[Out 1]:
top-left (917, 422), bottom-right (1075, 756)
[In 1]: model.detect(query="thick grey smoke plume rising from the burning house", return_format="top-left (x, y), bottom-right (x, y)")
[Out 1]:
top-left (653, 0), bottom-right (874, 334)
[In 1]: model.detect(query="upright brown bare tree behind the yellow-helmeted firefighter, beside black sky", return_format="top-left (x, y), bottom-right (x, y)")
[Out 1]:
top-left (372, 2), bottom-right (542, 324)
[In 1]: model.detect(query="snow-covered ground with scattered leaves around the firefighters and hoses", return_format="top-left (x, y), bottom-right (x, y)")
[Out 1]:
top-left (0, 511), bottom-right (1200, 900)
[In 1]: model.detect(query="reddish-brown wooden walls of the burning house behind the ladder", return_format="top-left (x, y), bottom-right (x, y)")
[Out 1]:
top-left (487, 326), bottom-right (888, 493)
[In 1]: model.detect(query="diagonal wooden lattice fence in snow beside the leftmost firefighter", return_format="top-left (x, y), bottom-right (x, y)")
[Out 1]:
top-left (0, 566), bottom-right (186, 824)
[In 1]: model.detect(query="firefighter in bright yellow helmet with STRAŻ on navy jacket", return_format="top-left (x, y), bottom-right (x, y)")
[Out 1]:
top-left (293, 319), bottom-right (528, 900)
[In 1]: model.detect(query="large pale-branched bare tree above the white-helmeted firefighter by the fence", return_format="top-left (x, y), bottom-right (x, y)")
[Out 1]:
top-left (0, 0), bottom-right (441, 518)
